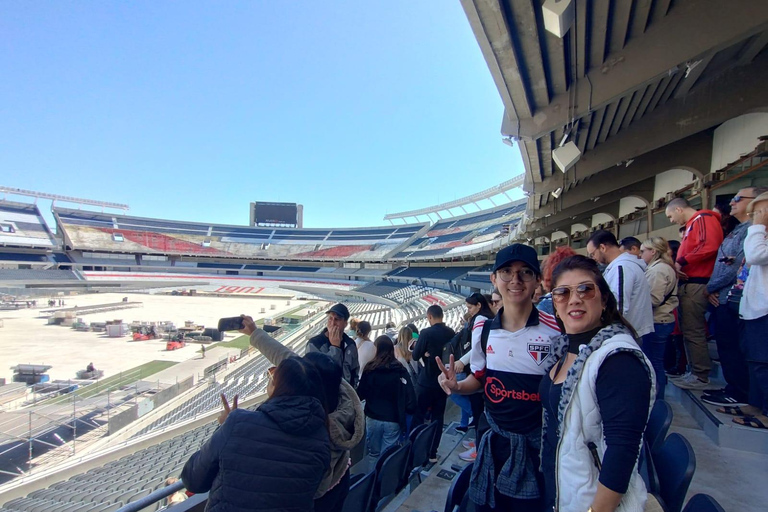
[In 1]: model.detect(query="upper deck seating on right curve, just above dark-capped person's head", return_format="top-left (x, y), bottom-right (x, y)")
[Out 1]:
top-left (394, 202), bottom-right (525, 260)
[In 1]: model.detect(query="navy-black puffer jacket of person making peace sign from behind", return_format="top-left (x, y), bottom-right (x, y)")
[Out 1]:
top-left (181, 396), bottom-right (331, 512)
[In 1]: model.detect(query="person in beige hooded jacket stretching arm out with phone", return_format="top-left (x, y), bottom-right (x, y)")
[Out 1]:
top-left (240, 315), bottom-right (365, 512)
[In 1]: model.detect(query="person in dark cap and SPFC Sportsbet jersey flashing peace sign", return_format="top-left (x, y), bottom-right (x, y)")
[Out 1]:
top-left (437, 244), bottom-right (560, 512)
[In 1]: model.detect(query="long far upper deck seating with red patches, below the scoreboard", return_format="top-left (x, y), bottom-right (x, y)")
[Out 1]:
top-left (54, 208), bottom-right (425, 262)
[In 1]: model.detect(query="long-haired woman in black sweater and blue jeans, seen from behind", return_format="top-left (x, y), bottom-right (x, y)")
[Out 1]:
top-left (357, 334), bottom-right (416, 471)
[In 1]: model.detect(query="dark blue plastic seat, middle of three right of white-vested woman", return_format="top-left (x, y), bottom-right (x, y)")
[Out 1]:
top-left (653, 433), bottom-right (696, 512)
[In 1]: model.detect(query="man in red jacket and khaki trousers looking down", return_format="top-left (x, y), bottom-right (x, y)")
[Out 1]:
top-left (666, 197), bottom-right (723, 389)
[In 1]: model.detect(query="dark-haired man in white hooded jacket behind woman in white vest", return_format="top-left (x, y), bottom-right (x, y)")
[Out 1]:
top-left (587, 229), bottom-right (653, 342)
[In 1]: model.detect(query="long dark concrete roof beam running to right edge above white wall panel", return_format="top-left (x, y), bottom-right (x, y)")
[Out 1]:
top-left (533, 52), bottom-right (768, 194)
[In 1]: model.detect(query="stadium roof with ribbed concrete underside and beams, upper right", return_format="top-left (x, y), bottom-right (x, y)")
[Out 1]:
top-left (462, 0), bottom-right (768, 234)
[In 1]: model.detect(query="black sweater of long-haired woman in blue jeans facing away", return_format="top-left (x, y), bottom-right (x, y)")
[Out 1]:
top-left (357, 361), bottom-right (416, 429)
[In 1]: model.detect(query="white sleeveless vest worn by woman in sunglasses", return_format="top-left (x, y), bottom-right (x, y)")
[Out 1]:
top-left (555, 333), bottom-right (656, 512)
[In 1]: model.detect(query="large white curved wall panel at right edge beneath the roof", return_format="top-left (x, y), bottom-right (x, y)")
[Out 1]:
top-left (710, 112), bottom-right (768, 172)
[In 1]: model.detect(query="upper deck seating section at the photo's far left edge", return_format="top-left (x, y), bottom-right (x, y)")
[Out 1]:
top-left (0, 201), bottom-right (58, 248)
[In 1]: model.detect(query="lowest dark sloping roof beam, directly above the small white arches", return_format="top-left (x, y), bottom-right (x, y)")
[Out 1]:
top-left (534, 130), bottom-right (714, 218)
